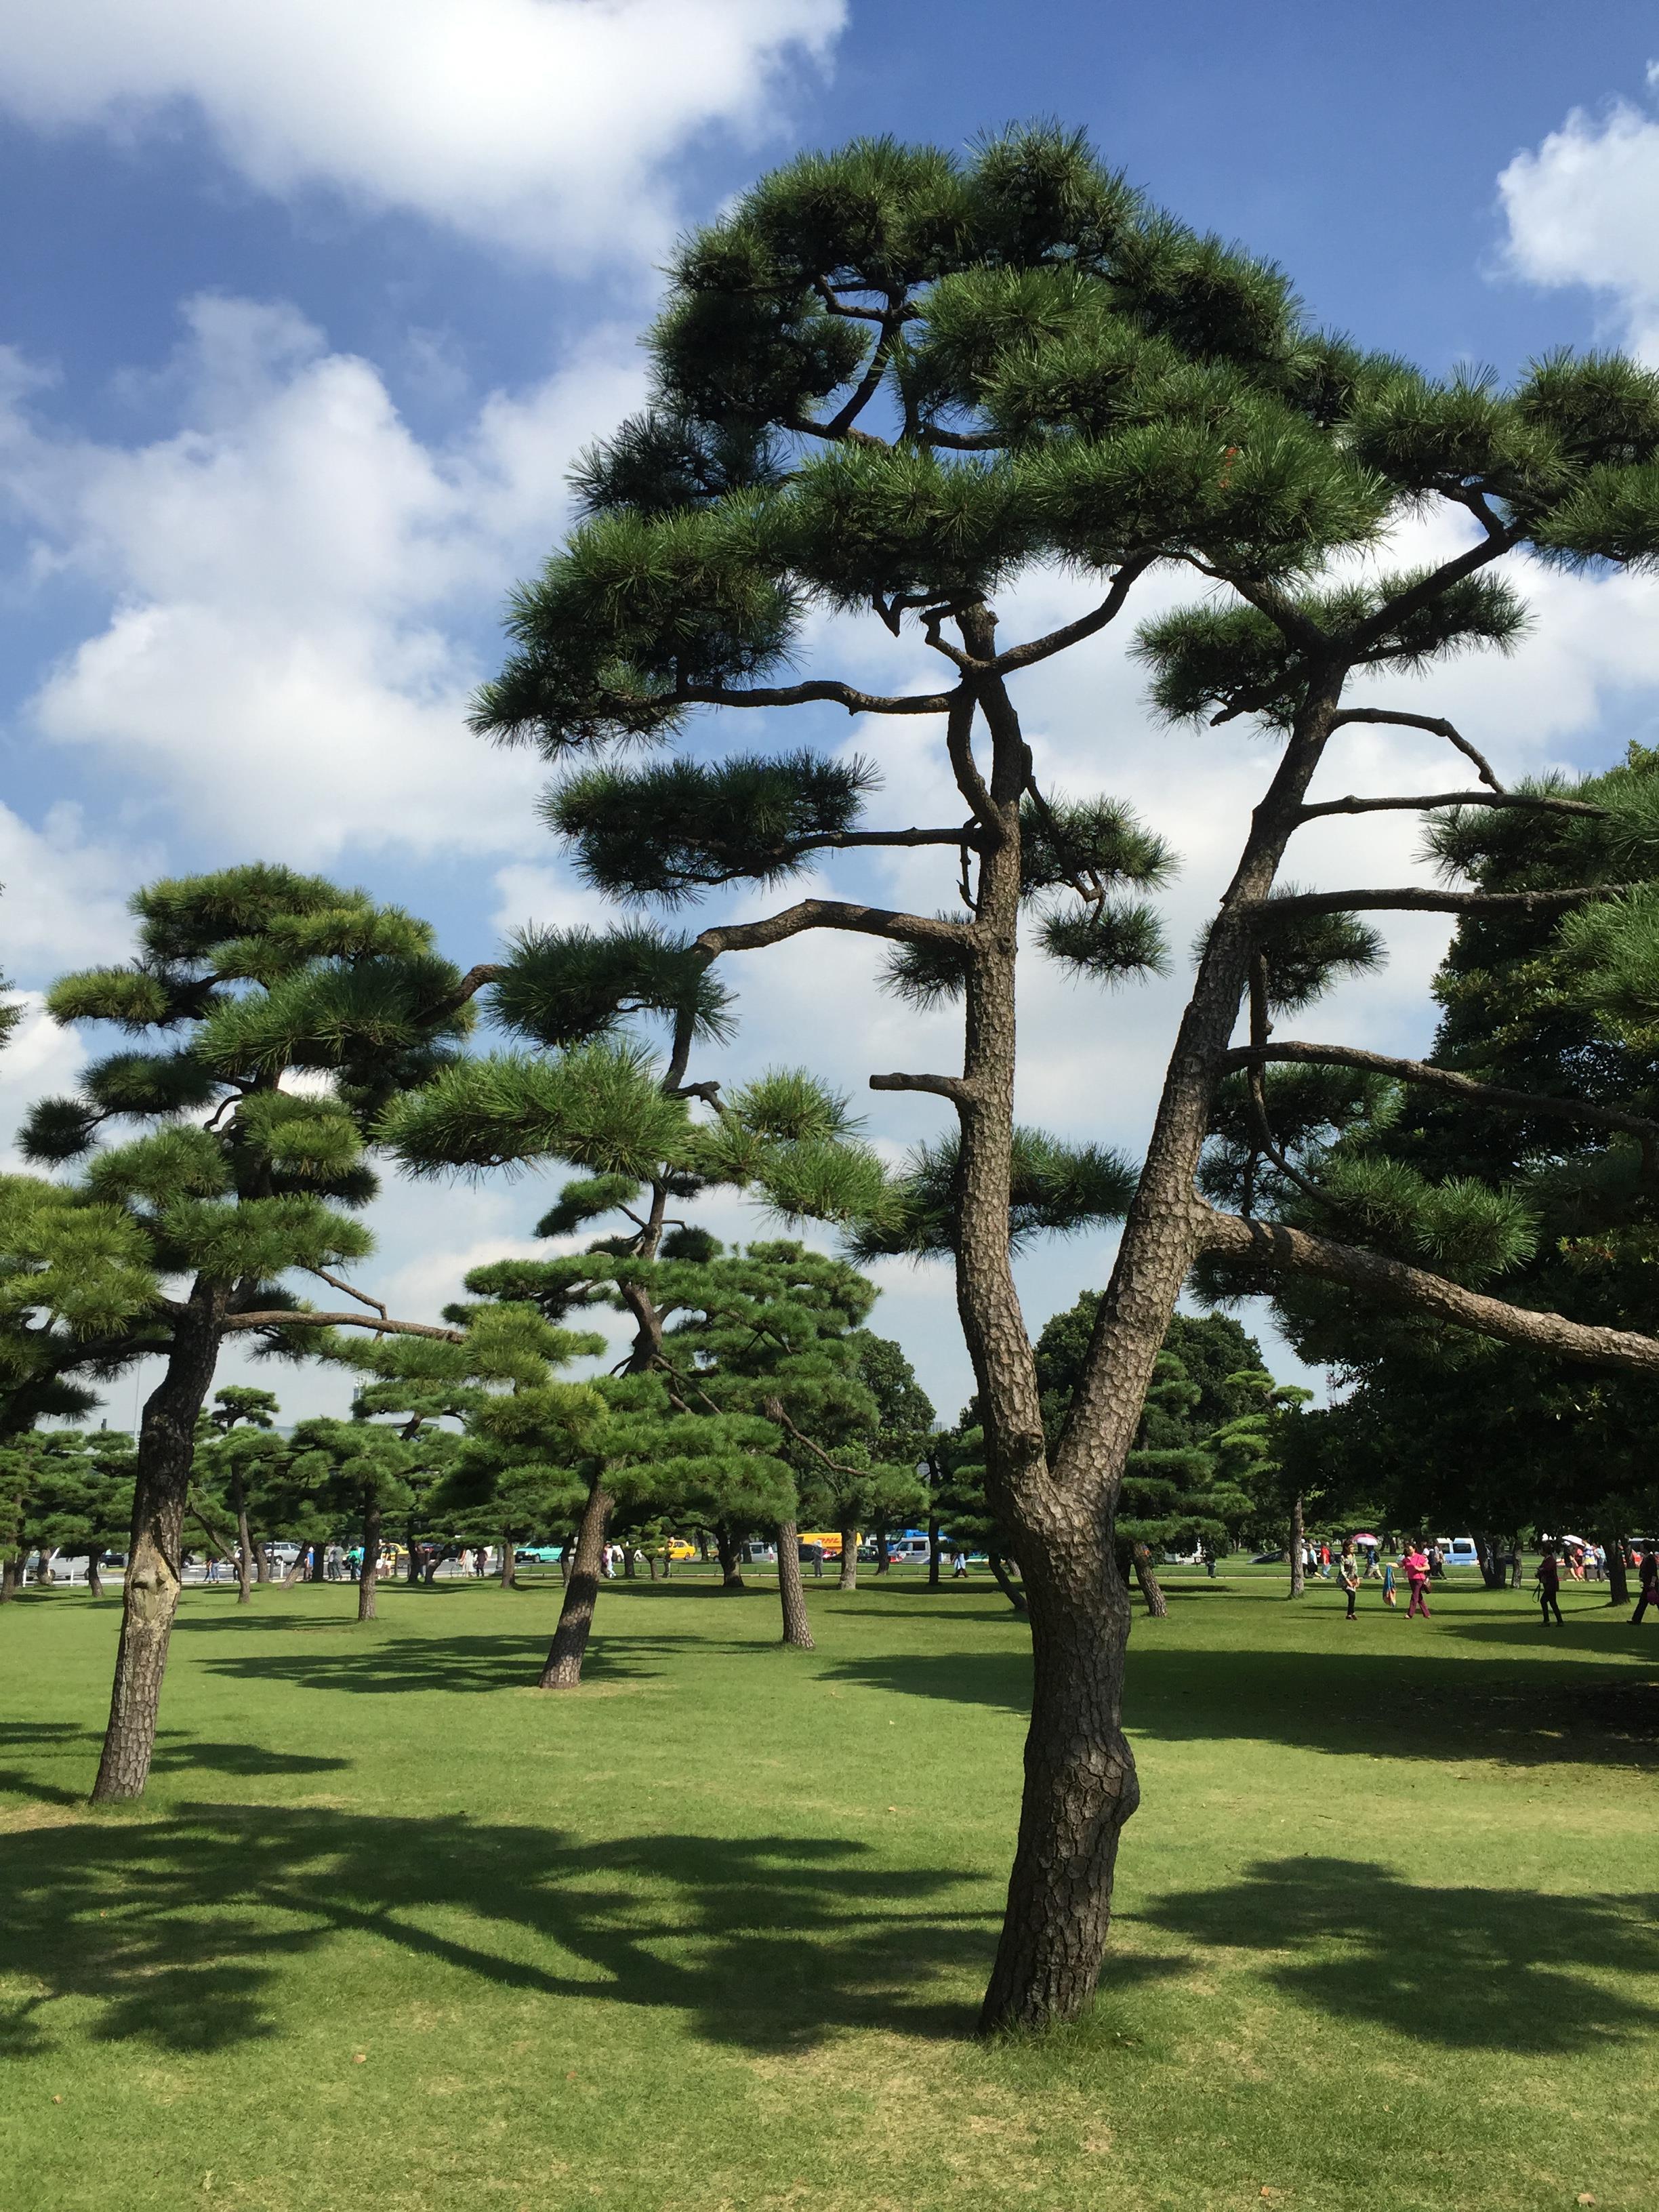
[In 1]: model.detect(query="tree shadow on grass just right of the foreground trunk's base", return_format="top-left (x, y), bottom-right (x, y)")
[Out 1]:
top-left (1132, 1858), bottom-right (1659, 2055)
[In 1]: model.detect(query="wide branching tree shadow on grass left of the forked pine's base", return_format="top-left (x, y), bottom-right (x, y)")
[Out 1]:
top-left (0, 1805), bottom-right (1040, 2055)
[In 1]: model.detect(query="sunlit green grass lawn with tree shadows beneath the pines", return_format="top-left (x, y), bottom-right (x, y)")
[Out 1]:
top-left (0, 1575), bottom-right (1659, 2212)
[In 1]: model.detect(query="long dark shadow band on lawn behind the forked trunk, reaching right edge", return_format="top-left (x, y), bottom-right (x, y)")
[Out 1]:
top-left (825, 1637), bottom-right (1659, 1767)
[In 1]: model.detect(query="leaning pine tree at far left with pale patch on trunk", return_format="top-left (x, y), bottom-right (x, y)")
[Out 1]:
top-left (11, 865), bottom-right (493, 1801)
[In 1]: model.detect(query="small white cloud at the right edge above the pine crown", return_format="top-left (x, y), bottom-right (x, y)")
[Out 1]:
top-left (1498, 64), bottom-right (1659, 356)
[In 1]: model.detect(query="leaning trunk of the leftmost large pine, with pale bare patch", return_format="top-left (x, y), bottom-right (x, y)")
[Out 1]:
top-left (93, 1281), bottom-right (228, 1805)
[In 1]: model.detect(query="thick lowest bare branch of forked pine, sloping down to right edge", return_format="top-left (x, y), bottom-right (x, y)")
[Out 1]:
top-left (1199, 1208), bottom-right (1659, 1376)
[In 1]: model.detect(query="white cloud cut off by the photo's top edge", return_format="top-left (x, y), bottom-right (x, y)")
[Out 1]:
top-left (0, 0), bottom-right (845, 268)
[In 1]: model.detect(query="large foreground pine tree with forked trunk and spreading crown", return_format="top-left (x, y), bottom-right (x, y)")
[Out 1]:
top-left (436, 128), bottom-right (1659, 2028)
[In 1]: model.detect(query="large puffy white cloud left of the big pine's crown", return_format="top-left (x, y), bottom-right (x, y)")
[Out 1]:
top-left (0, 299), bottom-right (642, 863)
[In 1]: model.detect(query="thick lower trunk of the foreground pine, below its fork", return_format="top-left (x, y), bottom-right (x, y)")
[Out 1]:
top-left (980, 1531), bottom-right (1139, 2033)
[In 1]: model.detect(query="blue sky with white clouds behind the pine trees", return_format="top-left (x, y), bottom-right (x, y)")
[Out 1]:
top-left (0, 0), bottom-right (1659, 1411)
